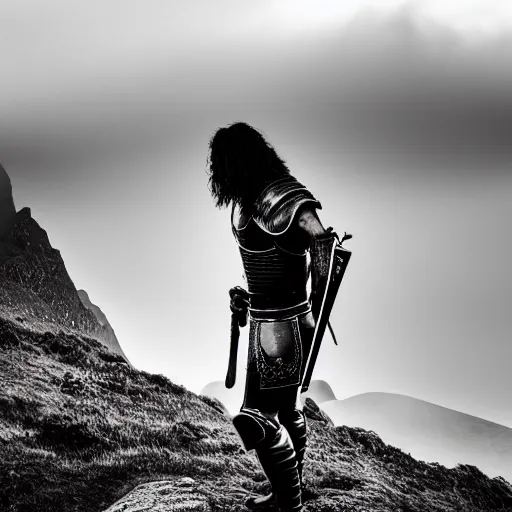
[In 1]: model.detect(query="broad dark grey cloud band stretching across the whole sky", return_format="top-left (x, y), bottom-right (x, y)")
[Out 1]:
top-left (0, 4), bottom-right (512, 175)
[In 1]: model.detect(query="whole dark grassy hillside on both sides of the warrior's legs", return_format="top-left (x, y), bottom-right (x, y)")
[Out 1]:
top-left (0, 318), bottom-right (512, 512)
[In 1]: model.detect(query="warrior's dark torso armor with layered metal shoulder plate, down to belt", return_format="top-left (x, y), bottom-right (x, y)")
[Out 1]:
top-left (231, 176), bottom-right (321, 319)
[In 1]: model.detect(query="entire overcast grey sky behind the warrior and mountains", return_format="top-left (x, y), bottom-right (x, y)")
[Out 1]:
top-left (0, 0), bottom-right (512, 427)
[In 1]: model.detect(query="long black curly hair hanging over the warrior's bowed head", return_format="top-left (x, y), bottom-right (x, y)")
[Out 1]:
top-left (207, 122), bottom-right (290, 208)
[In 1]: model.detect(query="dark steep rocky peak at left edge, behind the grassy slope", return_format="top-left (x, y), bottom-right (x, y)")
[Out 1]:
top-left (0, 169), bottom-right (126, 359)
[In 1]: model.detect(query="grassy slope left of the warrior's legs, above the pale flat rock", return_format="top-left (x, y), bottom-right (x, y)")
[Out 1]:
top-left (0, 319), bottom-right (253, 512)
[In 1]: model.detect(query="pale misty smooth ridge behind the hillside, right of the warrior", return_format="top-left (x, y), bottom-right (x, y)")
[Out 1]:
top-left (321, 392), bottom-right (512, 481)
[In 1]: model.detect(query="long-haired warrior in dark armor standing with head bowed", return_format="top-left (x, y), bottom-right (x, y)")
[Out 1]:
top-left (208, 122), bottom-right (350, 512)
